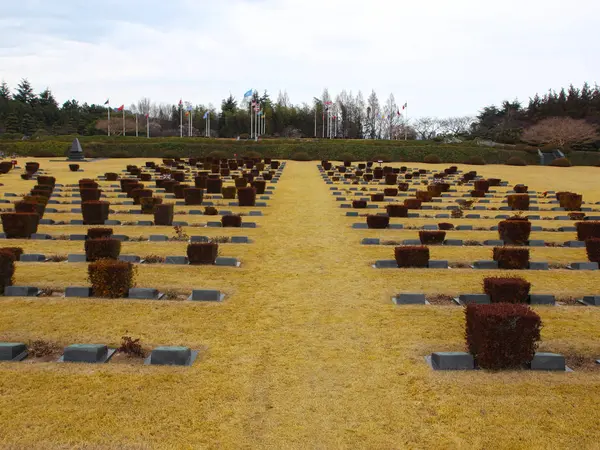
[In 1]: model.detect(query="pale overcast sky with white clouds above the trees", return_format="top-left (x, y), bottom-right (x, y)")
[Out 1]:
top-left (0, 0), bottom-right (600, 117)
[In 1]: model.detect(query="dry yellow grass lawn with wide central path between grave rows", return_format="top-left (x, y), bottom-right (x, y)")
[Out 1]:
top-left (0, 160), bottom-right (600, 448)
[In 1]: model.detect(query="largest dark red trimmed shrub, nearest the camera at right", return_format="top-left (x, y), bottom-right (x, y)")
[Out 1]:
top-left (465, 303), bottom-right (542, 370)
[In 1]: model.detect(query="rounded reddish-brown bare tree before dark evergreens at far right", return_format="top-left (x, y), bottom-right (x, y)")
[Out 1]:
top-left (521, 117), bottom-right (599, 147)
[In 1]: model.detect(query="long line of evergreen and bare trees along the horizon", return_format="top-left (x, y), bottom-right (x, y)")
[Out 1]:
top-left (0, 79), bottom-right (600, 147)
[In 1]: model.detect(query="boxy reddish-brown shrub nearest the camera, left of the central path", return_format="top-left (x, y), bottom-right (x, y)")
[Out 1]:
top-left (88, 259), bottom-right (137, 298)
